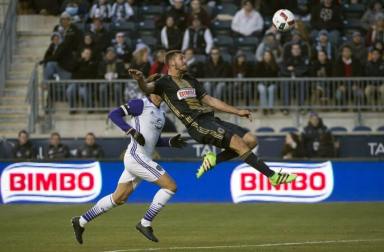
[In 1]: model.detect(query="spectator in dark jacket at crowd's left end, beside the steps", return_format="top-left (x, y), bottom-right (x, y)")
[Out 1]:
top-left (44, 12), bottom-right (81, 80)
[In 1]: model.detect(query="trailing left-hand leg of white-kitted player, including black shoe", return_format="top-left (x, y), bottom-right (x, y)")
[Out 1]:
top-left (71, 181), bottom-right (137, 244)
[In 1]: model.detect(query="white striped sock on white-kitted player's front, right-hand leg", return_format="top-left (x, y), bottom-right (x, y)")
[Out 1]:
top-left (141, 188), bottom-right (175, 227)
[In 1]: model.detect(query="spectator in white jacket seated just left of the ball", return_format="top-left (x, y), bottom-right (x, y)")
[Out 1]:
top-left (231, 0), bottom-right (264, 36)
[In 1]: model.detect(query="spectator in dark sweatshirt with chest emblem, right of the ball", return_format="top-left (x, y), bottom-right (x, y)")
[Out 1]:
top-left (311, 0), bottom-right (343, 46)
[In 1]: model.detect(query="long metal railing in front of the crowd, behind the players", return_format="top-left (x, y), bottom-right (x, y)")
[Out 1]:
top-left (42, 78), bottom-right (384, 130)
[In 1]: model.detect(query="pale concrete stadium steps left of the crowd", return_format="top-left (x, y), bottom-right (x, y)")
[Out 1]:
top-left (0, 15), bottom-right (54, 137)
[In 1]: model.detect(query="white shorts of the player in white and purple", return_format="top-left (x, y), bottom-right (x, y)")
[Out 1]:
top-left (119, 151), bottom-right (165, 186)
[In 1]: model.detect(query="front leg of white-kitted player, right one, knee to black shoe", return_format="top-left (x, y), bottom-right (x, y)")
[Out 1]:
top-left (136, 173), bottom-right (177, 242)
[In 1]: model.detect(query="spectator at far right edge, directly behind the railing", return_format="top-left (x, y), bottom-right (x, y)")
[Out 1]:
top-left (364, 49), bottom-right (384, 105)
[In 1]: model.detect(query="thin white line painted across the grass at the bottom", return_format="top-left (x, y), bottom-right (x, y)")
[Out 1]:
top-left (104, 239), bottom-right (384, 252)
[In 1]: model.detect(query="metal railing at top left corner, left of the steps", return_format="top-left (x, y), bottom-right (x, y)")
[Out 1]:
top-left (0, 1), bottom-right (17, 95)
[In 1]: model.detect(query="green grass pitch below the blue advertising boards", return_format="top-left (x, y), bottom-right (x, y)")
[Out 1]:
top-left (0, 203), bottom-right (384, 252)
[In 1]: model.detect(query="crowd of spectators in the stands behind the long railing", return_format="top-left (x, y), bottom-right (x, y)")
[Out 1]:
top-left (35, 0), bottom-right (384, 113)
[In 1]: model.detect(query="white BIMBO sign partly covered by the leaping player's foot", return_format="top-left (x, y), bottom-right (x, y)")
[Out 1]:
top-left (231, 161), bottom-right (333, 203)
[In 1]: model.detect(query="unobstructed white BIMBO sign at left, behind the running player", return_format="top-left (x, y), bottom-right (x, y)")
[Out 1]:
top-left (0, 162), bottom-right (102, 204)
